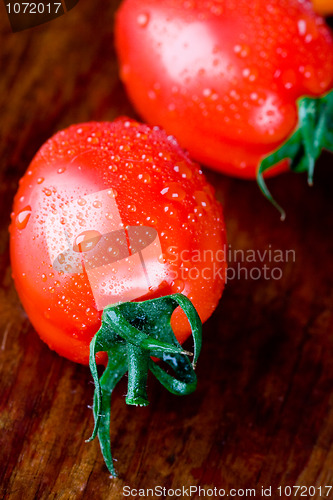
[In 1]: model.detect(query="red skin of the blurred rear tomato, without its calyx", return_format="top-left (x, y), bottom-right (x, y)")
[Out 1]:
top-left (115, 0), bottom-right (333, 178)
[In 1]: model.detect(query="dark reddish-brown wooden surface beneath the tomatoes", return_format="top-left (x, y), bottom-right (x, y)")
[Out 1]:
top-left (0, 0), bottom-right (333, 500)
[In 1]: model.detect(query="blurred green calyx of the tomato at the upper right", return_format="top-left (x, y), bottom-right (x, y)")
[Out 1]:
top-left (257, 90), bottom-right (333, 220)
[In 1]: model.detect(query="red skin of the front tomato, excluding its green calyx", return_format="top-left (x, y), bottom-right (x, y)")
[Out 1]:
top-left (10, 119), bottom-right (226, 364)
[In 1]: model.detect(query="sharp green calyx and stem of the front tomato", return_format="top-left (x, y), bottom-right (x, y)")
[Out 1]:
top-left (88, 294), bottom-right (202, 477)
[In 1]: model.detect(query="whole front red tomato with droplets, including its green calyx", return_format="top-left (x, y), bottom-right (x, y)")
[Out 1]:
top-left (10, 119), bottom-right (226, 474)
